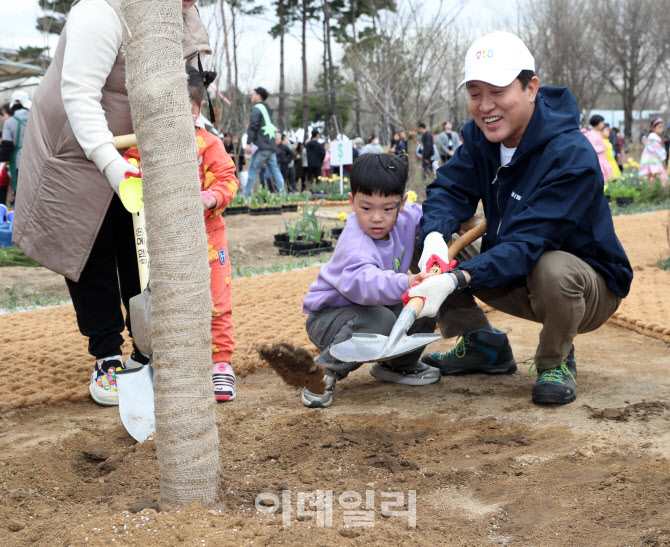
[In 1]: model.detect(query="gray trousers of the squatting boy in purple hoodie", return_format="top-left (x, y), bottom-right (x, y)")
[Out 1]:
top-left (306, 304), bottom-right (437, 380)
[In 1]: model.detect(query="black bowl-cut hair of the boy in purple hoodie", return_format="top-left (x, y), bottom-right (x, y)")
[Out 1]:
top-left (349, 154), bottom-right (407, 197)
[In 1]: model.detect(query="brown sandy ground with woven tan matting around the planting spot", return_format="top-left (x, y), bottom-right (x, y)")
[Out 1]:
top-left (0, 212), bottom-right (670, 546)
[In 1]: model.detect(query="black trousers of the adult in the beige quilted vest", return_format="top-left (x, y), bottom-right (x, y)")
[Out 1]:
top-left (65, 194), bottom-right (140, 359)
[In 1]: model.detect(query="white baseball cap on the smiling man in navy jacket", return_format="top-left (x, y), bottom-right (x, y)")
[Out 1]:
top-left (456, 30), bottom-right (535, 89)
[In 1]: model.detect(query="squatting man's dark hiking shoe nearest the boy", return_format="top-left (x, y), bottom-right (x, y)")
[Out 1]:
top-left (421, 329), bottom-right (516, 376)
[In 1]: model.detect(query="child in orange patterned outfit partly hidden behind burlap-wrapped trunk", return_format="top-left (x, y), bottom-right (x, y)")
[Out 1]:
top-left (124, 66), bottom-right (239, 401)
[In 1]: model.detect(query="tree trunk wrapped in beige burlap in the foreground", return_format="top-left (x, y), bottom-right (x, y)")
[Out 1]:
top-left (121, 0), bottom-right (219, 509)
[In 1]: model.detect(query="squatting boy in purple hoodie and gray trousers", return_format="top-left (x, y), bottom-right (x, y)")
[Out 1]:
top-left (301, 154), bottom-right (441, 408)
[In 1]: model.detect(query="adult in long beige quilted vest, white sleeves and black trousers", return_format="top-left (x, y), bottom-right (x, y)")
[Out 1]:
top-left (13, 0), bottom-right (211, 405)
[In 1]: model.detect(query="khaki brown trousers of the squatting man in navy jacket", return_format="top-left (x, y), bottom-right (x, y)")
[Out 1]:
top-left (438, 242), bottom-right (621, 369)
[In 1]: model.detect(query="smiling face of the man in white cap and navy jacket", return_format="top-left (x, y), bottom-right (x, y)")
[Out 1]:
top-left (466, 76), bottom-right (540, 148)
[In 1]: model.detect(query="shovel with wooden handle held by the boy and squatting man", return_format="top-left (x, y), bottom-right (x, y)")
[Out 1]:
top-left (330, 221), bottom-right (486, 363)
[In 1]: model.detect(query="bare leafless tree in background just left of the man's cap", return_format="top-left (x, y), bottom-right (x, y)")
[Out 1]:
top-left (344, 1), bottom-right (469, 178)
